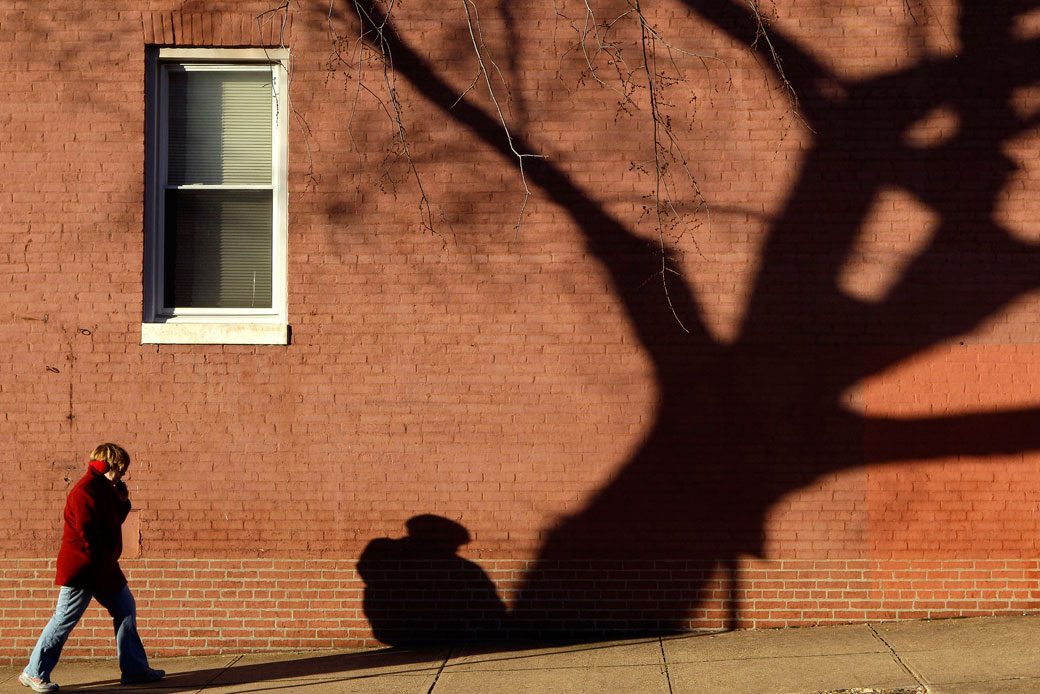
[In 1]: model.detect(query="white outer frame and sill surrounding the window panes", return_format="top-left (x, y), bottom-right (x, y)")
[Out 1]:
top-left (141, 47), bottom-right (289, 344)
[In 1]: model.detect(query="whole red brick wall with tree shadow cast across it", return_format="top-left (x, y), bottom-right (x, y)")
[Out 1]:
top-left (0, 0), bottom-right (1040, 661)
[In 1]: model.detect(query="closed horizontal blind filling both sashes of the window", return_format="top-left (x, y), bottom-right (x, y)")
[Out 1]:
top-left (163, 67), bottom-right (274, 309)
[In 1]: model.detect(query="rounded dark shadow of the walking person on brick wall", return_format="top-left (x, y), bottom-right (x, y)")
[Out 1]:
top-left (358, 514), bottom-right (505, 646)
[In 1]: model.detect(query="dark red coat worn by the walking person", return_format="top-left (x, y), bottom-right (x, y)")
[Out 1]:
top-left (54, 467), bottom-right (130, 592)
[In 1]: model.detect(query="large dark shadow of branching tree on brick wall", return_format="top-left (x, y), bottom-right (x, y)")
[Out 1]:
top-left (345, 0), bottom-right (1040, 635)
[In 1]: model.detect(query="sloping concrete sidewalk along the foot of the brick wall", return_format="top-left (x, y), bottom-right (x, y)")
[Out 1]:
top-left (0, 616), bottom-right (1040, 694)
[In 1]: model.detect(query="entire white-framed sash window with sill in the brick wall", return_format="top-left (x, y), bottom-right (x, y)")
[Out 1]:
top-left (141, 49), bottom-right (288, 344)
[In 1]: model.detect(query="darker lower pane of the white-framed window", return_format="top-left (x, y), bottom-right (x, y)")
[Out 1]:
top-left (164, 189), bottom-right (272, 308)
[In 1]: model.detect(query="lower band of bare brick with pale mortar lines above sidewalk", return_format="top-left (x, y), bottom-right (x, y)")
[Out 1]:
top-left (0, 559), bottom-right (1040, 664)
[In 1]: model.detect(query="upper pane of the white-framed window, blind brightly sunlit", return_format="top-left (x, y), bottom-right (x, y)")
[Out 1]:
top-left (166, 70), bottom-right (271, 185)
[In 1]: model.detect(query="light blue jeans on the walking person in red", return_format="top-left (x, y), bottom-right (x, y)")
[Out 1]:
top-left (25, 586), bottom-right (148, 680)
